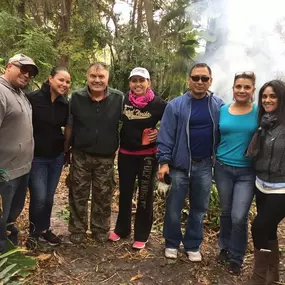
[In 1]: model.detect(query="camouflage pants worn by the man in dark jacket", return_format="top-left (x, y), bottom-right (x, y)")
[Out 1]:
top-left (68, 150), bottom-right (114, 241)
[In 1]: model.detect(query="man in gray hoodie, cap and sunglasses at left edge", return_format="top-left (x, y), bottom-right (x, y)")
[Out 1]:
top-left (0, 54), bottom-right (38, 253)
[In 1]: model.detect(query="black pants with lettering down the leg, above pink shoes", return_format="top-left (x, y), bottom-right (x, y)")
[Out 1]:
top-left (115, 153), bottom-right (158, 241)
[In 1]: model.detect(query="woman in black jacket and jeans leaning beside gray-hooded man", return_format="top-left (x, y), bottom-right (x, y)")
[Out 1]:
top-left (26, 67), bottom-right (70, 249)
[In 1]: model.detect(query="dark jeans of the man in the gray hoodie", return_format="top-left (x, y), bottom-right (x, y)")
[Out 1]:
top-left (0, 174), bottom-right (29, 252)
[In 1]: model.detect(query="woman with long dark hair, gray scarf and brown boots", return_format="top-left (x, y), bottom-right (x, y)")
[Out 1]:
top-left (245, 80), bottom-right (285, 285)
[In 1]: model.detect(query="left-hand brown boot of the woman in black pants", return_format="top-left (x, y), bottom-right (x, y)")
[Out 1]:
top-left (243, 246), bottom-right (271, 285)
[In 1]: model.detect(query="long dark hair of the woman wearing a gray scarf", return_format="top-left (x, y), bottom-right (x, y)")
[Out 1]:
top-left (258, 80), bottom-right (285, 126)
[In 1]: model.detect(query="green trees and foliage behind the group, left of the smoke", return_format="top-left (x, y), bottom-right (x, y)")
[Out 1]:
top-left (0, 0), bottom-right (199, 94)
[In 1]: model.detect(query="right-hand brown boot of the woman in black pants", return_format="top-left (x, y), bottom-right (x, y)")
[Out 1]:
top-left (266, 240), bottom-right (279, 285)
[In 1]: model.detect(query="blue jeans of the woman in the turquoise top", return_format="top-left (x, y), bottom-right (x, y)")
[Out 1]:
top-left (215, 161), bottom-right (255, 265)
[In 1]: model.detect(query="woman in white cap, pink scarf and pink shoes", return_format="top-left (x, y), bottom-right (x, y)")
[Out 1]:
top-left (109, 67), bottom-right (166, 249)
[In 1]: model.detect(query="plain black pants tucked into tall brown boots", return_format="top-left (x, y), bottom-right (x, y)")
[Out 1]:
top-left (251, 189), bottom-right (285, 249)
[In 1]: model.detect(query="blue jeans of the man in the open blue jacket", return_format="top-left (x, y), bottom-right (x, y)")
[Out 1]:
top-left (163, 158), bottom-right (212, 251)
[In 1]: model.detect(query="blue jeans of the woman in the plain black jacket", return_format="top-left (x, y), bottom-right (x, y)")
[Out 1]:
top-left (29, 153), bottom-right (64, 234)
